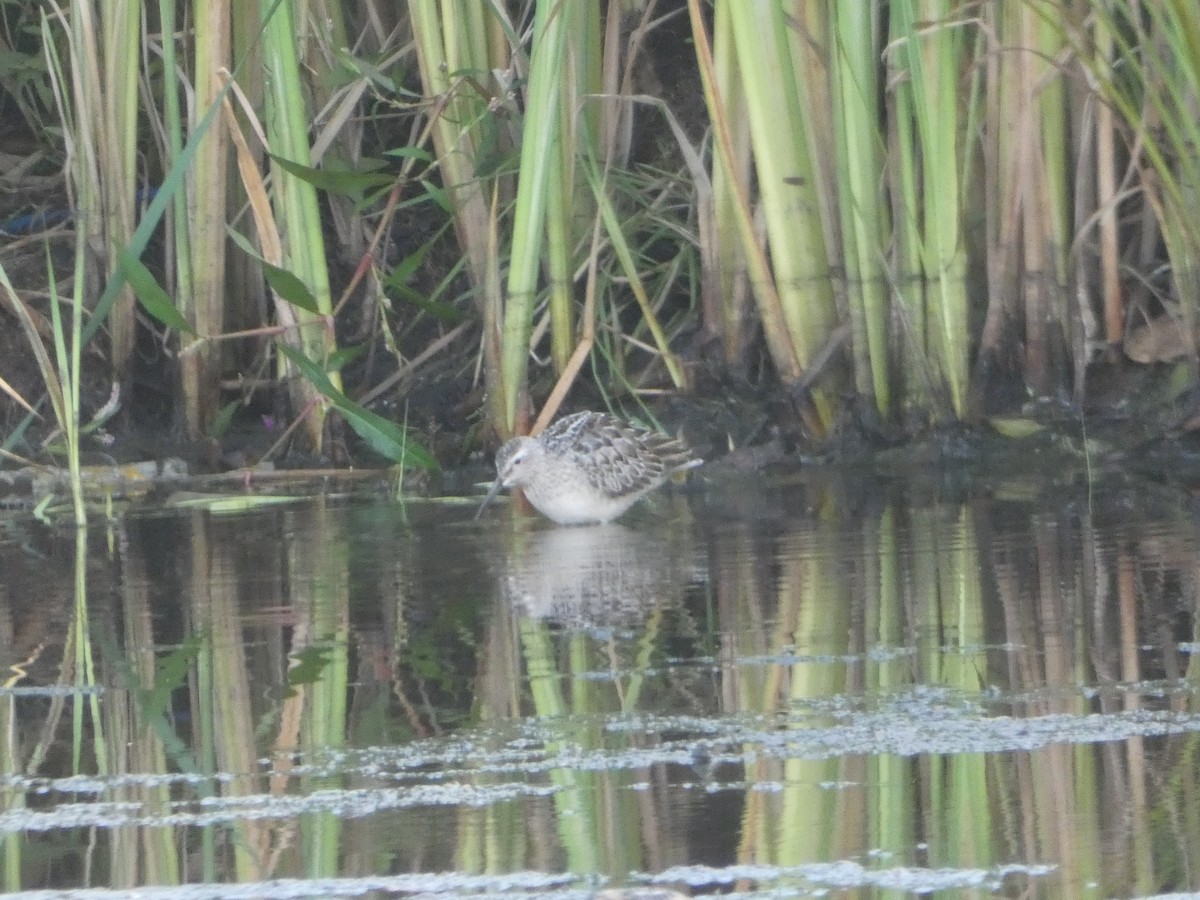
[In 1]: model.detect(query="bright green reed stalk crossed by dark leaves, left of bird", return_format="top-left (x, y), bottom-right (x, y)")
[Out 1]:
top-left (262, 0), bottom-right (342, 450)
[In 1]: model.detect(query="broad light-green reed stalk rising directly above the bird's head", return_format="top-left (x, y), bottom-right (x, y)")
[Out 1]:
top-left (499, 2), bottom-right (569, 433)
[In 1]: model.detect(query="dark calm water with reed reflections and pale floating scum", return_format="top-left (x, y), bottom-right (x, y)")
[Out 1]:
top-left (0, 472), bottom-right (1200, 898)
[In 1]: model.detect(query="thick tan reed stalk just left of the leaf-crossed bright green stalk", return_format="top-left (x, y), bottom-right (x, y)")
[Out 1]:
top-left (181, 0), bottom-right (232, 438)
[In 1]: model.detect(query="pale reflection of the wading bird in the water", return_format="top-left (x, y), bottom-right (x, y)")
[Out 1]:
top-left (497, 523), bottom-right (689, 628)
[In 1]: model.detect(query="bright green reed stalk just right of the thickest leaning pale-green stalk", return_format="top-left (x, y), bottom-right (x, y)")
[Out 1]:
top-left (829, 0), bottom-right (892, 416)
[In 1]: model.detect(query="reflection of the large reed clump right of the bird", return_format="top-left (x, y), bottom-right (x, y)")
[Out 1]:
top-left (713, 489), bottom-right (1200, 893)
